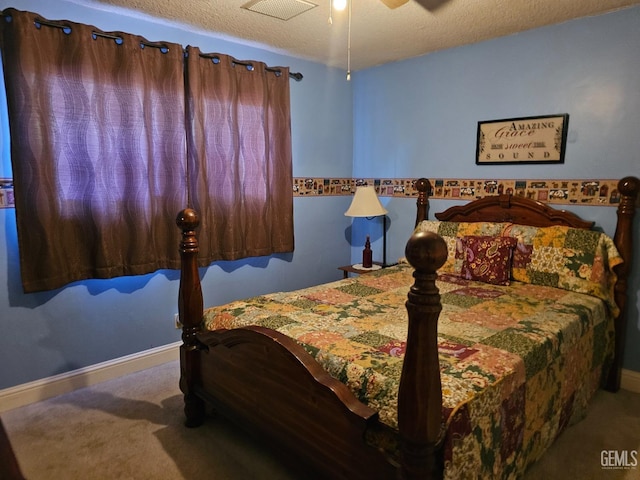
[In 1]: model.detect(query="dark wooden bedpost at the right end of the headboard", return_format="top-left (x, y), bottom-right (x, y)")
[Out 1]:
top-left (606, 177), bottom-right (640, 392)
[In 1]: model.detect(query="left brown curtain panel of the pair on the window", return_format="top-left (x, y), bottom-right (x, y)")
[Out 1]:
top-left (1, 9), bottom-right (188, 292)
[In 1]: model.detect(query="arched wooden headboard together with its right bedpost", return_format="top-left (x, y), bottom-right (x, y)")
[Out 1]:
top-left (432, 177), bottom-right (640, 391)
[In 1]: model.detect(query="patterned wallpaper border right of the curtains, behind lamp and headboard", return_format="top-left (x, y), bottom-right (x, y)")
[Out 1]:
top-left (293, 177), bottom-right (620, 206)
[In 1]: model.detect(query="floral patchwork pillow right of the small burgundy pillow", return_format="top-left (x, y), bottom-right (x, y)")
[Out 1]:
top-left (504, 224), bottom-right (622, 315)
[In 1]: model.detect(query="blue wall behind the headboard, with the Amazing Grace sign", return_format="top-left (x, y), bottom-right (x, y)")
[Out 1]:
top-left (353, 7), bottom-right (640, 371)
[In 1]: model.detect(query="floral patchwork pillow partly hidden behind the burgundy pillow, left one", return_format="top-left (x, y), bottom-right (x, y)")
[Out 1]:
top-left (415, 220), bottom-right (511, 275)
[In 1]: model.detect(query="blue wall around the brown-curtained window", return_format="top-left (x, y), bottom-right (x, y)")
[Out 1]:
top-left (0, 0), bottom-right (353, 389)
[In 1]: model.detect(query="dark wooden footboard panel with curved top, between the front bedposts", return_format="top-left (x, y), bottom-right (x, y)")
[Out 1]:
top-left (197, 326), bottom-right (397, 479)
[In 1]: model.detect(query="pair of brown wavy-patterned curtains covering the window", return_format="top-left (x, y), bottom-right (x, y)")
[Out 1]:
top-left (0, 9), bottom-right (294, 292)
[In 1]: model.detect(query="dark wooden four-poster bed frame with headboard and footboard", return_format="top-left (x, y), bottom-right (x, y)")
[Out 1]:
top-left (177, 177), bottom-right (640, 480)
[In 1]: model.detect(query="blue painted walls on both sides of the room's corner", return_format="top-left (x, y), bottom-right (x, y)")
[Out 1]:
top-left (0, 0), bottom-right (640, 388)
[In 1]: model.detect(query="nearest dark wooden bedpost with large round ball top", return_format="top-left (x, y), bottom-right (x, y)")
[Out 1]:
top-left (398, 232), bottom-right (447, 480)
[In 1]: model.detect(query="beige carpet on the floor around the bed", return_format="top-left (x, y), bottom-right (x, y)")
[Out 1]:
top-left (2, 362), bottom-right (640, 480)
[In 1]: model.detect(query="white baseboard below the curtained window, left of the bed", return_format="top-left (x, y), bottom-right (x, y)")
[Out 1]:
top-left (0, 342), bottom-right (182, 413)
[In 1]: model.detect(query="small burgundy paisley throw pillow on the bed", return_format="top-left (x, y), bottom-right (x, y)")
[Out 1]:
top-left (461, 235), bottom-right (518, 285)
